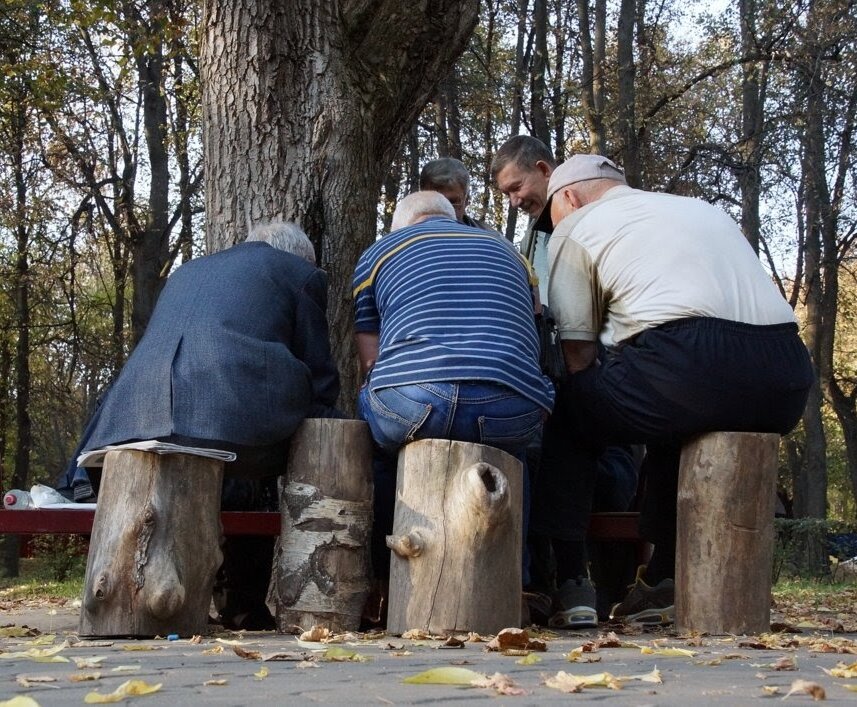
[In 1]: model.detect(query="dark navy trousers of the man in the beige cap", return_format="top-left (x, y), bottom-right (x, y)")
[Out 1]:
top-left (546, 318), bottom-right (813, 576)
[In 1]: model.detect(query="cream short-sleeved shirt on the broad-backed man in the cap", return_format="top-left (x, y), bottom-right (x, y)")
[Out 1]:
top-left (548, 186), bottom-right (795, 346)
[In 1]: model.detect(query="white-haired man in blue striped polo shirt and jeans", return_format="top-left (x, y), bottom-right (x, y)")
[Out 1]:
top-left (354, 191), bottom-right (554, 620)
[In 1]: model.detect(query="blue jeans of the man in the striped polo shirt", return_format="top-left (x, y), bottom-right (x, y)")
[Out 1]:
top-left (357, 382), bottom-right (545, 584)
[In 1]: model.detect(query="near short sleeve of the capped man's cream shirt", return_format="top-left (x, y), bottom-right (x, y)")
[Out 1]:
top-left (548, 232), bottom-right (601, 341)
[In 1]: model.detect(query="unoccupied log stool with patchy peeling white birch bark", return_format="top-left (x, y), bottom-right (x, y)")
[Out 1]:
top-left (268, 418), bottom-right (372, 633)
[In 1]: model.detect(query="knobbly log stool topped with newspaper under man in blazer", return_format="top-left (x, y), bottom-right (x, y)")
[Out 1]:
top-left (79, 450), bottom-right (223, 637)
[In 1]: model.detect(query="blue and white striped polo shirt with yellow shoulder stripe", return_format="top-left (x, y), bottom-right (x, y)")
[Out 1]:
top-left (354, 218), bottom-right (554, 411)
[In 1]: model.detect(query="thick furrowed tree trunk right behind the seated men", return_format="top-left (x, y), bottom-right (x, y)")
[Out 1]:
top-left (201, 0), bottom-right (478, 408)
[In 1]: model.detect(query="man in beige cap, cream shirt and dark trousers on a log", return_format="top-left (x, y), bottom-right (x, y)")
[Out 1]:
top-left (545, 155), bottom-right (813, 623)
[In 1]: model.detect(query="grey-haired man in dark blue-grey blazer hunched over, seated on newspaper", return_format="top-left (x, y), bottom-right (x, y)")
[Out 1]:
top-left (59, 222), bottom-right (339, 628)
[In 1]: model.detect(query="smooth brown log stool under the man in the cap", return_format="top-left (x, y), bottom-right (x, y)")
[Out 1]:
top-left (675, 432), bottom-right (780, 635)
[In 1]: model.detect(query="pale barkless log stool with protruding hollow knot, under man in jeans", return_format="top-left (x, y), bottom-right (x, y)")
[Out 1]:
top-left (387, 439), bottom-right (523, 634)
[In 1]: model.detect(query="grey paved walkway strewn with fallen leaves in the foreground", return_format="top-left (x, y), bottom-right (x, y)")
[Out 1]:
top-left (0, 607), bottom-right (857, 707)
